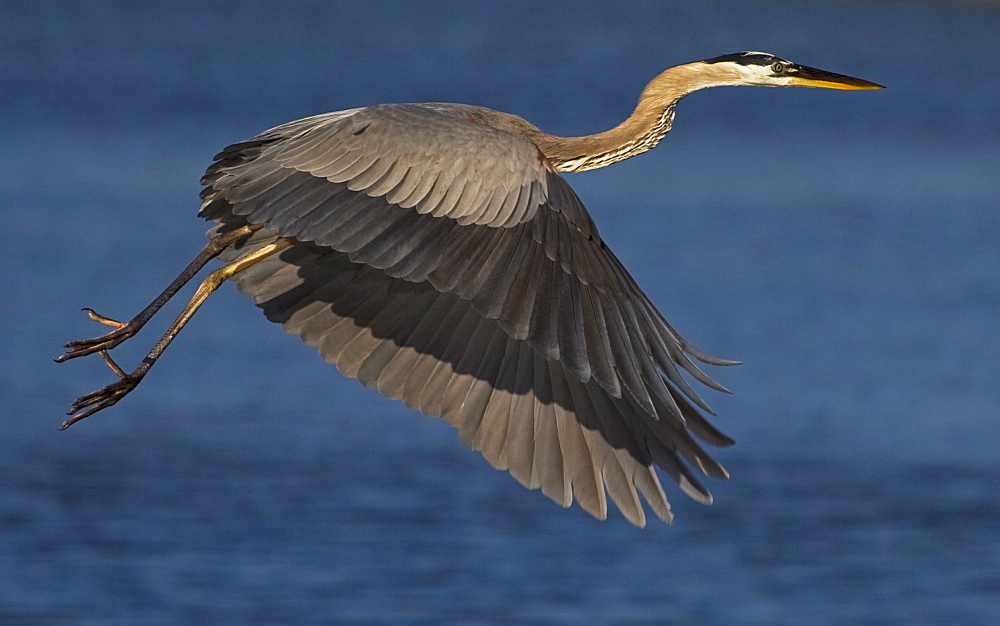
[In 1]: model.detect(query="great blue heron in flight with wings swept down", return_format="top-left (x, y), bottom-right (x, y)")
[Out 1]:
top-left (57, 52), bottom-right (880, 526)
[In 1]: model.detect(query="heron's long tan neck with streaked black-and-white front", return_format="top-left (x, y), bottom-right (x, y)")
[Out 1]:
top-left (530, 63), bottom-right (726, 172)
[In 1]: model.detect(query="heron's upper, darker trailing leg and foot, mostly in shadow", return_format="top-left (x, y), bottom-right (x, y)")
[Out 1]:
top-left (56, 224), bottom-right (262, 363)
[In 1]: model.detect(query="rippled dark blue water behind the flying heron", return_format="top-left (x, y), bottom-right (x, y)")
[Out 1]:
top-left (0, 1), bottom-right (1000, 623)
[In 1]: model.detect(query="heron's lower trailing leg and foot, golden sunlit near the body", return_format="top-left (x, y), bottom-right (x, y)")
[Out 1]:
top-left (60, 237), bottom-right (295, 430)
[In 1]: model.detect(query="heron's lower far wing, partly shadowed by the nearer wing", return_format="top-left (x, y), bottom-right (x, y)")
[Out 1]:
top-left (211, 221), bottom-right (728, 525)
